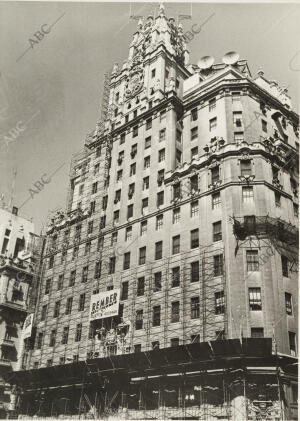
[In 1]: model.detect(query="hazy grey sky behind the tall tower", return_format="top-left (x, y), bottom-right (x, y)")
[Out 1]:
top-left (0, 2), bottom-right (300, 232)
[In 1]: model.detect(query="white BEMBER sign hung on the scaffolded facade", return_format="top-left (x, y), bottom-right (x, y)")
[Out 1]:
top-left (90, 289), bottom-right (120, 320)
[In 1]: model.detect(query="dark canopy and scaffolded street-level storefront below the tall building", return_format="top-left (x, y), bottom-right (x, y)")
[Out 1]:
top-left (7, 338), bottom-right (297, 420)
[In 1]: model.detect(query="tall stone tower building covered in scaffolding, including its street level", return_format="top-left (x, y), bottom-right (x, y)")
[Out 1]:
top-left (11, 7), bottom-right (299, 420)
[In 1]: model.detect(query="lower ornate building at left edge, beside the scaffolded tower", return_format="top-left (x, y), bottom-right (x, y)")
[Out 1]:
top-left (0, 207), bottom-right (40, 418)
